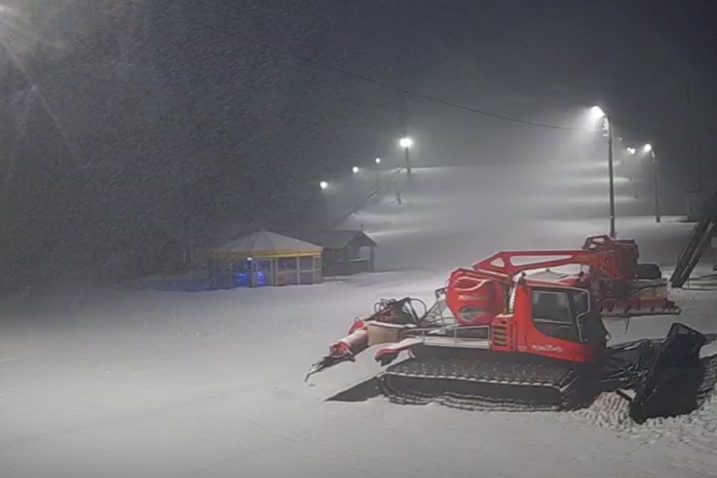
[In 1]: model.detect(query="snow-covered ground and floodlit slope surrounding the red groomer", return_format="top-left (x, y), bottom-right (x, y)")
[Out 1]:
top-left (0, 167), bottom-right (717, 478)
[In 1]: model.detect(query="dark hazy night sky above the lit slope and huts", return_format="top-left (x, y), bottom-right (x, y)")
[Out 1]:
top-left (0, 0), bottom-right (717, 286)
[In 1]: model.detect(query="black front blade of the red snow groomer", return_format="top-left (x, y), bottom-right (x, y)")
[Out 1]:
top-left (630, 323), bottom-right (707, 423)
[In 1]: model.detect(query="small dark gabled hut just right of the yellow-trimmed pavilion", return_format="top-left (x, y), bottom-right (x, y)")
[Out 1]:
top-left (309, 229), bottom-right (376, 275)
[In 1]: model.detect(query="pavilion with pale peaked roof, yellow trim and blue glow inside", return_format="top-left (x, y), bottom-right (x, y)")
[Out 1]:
top-left (207, 230), bottom-right (323, 288)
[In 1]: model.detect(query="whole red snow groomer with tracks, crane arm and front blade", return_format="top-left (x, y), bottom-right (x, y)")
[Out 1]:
top-left (307, 236), bottom-right (705, 422)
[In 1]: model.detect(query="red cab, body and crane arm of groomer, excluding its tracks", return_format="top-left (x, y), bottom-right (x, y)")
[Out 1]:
top-left (311, 236), bottom-right (679, 380)
